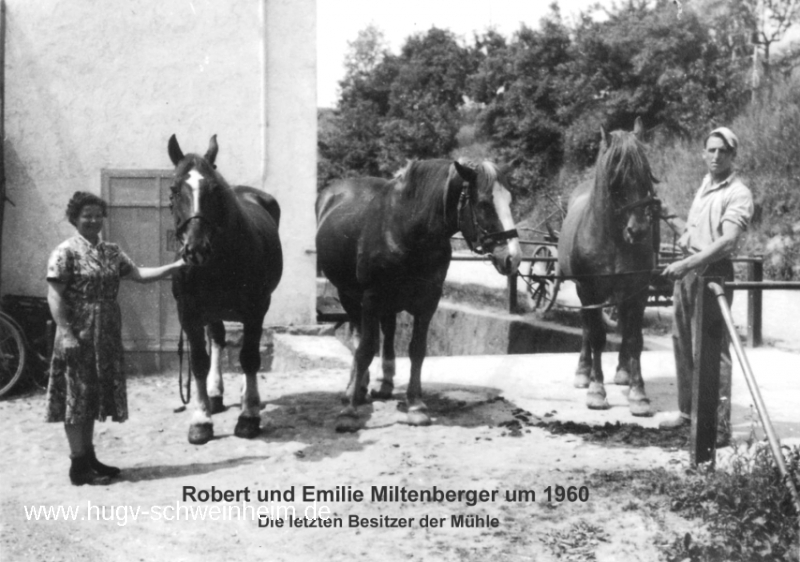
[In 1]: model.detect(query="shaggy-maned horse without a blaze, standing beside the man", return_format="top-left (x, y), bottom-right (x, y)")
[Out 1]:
top-left (558, 118), bottom-right (659, 416)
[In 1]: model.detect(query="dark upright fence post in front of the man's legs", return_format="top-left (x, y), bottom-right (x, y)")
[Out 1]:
top-left (689, 277), bottom-right (724, 466)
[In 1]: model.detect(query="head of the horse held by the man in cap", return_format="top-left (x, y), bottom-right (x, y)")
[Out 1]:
top-left (595, 117), bottom-right (660, 244)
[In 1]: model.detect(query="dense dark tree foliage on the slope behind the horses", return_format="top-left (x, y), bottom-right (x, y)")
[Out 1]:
top-left (320, 0), bottom-right (750, 198)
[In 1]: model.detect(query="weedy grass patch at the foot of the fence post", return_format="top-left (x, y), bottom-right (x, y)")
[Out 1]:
top-left (588, 442), bottom-right (800, 562)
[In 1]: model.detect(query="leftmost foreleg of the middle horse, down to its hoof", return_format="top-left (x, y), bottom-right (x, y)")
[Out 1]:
top-left (336, 299), bottom-right (380, 432)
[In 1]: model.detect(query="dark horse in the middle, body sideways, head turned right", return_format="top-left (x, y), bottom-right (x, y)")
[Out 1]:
top-left (316, 160), bottom-right (520, 431)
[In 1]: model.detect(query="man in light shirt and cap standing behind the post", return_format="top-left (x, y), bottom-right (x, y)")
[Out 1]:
top-left (660, 127), bottom-right (753, 446)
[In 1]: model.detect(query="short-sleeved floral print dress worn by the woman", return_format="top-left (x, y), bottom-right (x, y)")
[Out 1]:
top-left (46, 235), bottom-right (135, 424)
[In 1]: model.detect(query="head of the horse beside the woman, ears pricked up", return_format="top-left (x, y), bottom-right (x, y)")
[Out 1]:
top-left (168, 135), bottom-right (225, 265)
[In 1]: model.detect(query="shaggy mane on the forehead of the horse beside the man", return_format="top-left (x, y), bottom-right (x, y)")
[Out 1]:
top-left (595, 131), bottom-right (654, 200)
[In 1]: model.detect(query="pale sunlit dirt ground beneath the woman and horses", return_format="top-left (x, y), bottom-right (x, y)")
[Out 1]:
top-left (7, 334), bottom-right (800, 562)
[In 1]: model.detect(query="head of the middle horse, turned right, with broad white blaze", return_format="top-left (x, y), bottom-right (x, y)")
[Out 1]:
top-left (449, 162), bottom-right (522, 275)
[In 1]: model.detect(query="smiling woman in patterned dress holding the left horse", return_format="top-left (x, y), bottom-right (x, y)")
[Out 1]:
top-left (47, 191), bottom-right (184, 486)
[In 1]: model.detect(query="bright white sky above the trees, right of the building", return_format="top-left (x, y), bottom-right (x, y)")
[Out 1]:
top-left (317, 0), bottom-right (611, 107)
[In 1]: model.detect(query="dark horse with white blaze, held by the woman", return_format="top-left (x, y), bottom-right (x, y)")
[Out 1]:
top-left (168, 135), bottom-right (283, 445)
